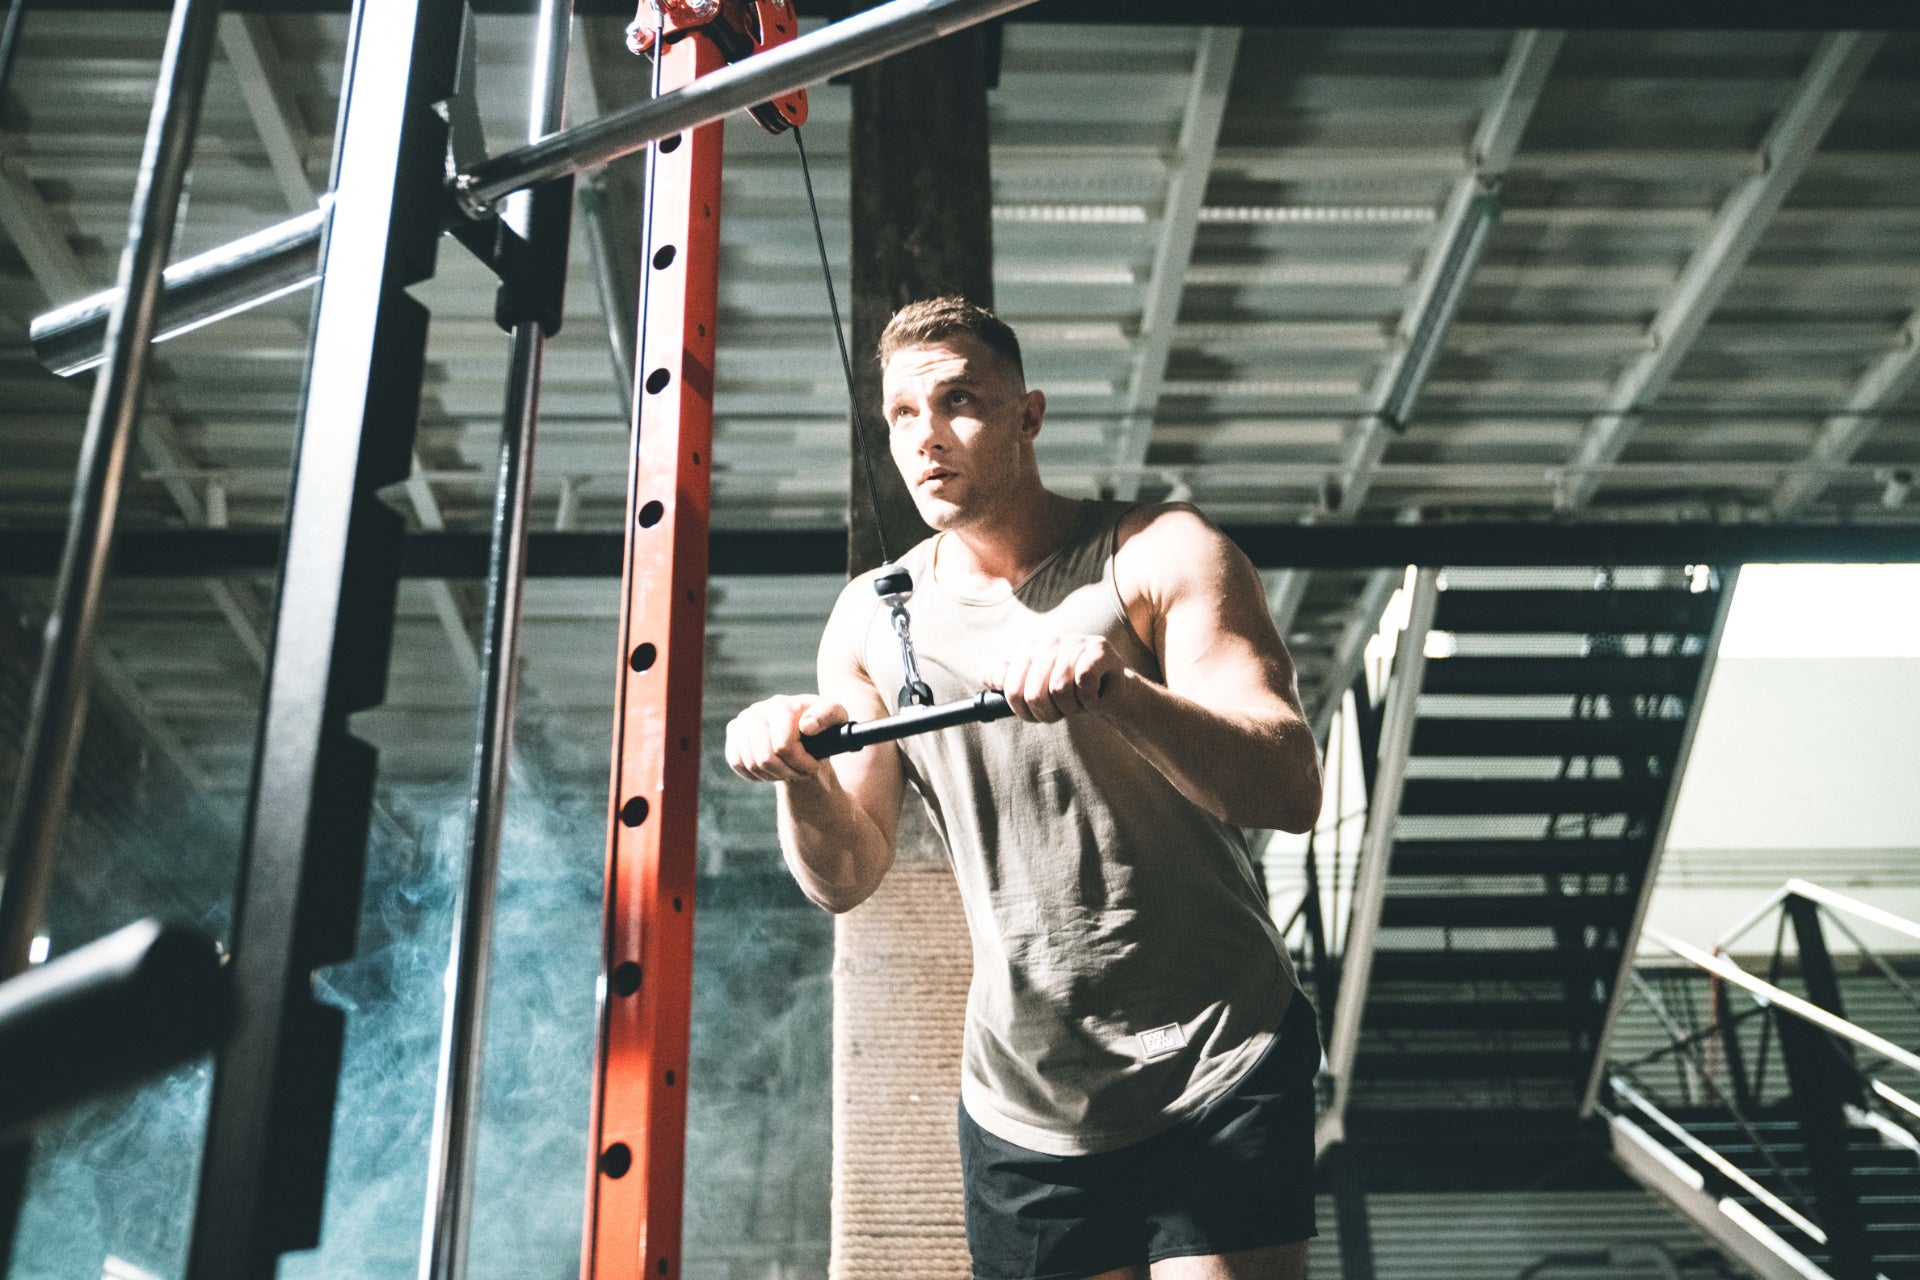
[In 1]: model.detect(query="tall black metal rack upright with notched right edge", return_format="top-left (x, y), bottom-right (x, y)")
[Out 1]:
top-left (186, 0), bottom-right (463, 1280)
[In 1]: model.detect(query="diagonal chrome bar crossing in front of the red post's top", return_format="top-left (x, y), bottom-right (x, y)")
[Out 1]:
top-left (453, 0), bottom-right (1033, 217)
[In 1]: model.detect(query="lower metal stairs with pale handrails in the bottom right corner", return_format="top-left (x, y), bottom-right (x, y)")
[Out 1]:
top-left (1601, 881), bottom-right (1920, 1280)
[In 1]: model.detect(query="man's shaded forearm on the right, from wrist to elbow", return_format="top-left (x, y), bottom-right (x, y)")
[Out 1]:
top-left (1106, 672), bottom-right (1321, 831)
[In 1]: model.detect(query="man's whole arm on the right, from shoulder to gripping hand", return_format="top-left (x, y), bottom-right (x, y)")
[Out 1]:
top-left (989, 505), bottom-right (1321, 831)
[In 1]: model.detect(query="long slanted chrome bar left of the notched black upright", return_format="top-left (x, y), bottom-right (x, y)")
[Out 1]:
top-left (0, 0), bottom-right (221, 979)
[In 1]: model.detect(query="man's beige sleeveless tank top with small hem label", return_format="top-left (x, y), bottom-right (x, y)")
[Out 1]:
top-left (849, 503), bottom-right (1296, 1155)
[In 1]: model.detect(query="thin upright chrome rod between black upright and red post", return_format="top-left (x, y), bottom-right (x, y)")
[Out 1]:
top-left (420, 0), bottom-right (574, 1280)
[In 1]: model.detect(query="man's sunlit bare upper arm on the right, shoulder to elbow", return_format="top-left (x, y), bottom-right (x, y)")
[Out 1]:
top-left (1131, 510), bottom-right (1302, 720)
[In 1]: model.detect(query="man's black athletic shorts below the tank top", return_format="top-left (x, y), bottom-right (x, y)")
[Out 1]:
top-left (960, 992), bottom-right (1321, 1280)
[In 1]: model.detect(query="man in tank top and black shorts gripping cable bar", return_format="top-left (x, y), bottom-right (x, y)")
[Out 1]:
top-left (728, 297), bottom-right (1321, 1280)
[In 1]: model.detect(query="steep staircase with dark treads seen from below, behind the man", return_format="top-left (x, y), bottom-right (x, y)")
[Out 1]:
top-left (1319, 568), bottom-right (1732, 1150)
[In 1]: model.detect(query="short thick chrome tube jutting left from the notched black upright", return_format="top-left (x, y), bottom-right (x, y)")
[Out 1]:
top-left (33, 208), bottom-right (326, 378)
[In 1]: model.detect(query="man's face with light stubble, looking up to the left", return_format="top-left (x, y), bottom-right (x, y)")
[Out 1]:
top-left (881, 334), bottom-right (1046, 530)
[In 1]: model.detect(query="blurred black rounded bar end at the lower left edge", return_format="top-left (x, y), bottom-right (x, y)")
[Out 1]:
top-left (0, 919), bottom-right (228, 1138)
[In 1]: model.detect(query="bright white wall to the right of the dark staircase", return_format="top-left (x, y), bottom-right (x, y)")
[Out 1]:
top-left (1647, 566), bottom-right (1920, 952)
